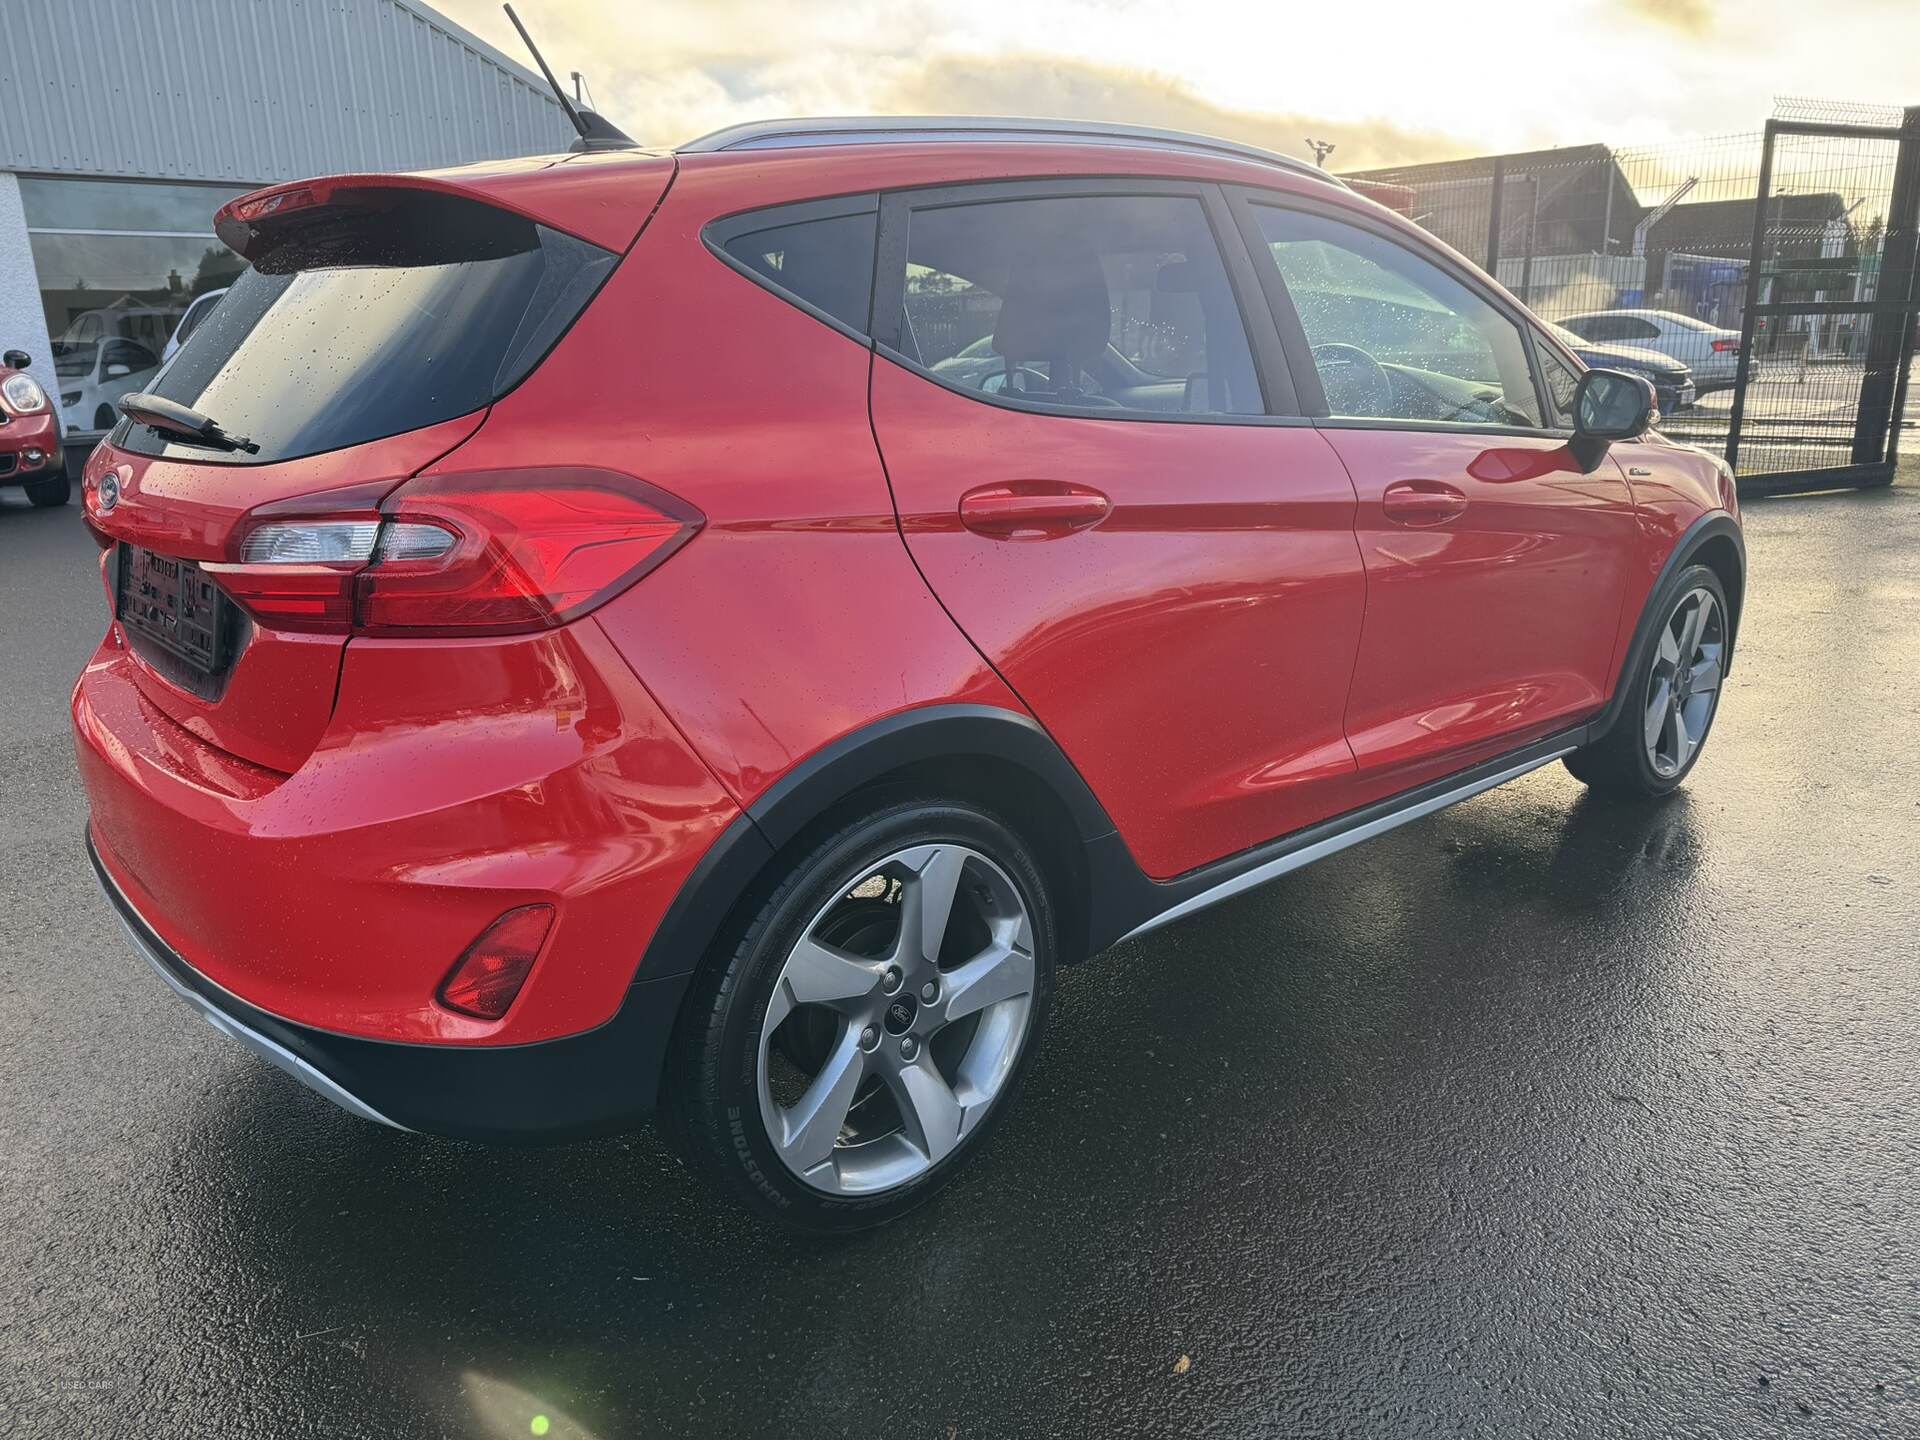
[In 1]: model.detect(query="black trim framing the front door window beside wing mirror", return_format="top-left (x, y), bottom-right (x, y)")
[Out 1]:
top-left (1223, 184), bottom-right (1571, 440)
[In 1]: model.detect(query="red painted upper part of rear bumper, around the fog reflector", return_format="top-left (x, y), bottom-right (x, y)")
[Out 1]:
top-left (73, 620), bottom-right (737, 1044)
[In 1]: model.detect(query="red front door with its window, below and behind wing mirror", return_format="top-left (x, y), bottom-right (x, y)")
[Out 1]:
top-left (1236, 192), bottom-right (1636, 799)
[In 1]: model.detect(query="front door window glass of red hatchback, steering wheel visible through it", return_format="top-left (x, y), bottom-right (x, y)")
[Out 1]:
top-left (1254, 205), bottom-right (1540, 428)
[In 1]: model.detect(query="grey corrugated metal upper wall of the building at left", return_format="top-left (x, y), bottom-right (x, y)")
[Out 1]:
top-left (0, 0), bottom-right (572, 182)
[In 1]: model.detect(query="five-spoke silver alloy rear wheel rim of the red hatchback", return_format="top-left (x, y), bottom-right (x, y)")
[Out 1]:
top-left (756, 843), bottom-right (1035, 1196)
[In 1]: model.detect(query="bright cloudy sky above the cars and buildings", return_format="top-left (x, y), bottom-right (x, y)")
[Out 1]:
top-left (428, 0), bottom-right (1920, 169)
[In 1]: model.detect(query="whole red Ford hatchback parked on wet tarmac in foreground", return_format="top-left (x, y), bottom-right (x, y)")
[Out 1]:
top-left (73, 121), bottom-right (1743, 1229)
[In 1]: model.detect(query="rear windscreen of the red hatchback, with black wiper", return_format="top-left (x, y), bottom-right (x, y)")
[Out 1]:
top-left (113, 192), bottom-right (618, 465)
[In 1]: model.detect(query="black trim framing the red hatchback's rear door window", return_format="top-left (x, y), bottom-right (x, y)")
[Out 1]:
top-left (872, 175), bottom-right (1313, 426)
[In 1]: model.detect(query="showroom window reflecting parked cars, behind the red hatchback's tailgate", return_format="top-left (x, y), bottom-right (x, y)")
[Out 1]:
top-left (19, 177), bottom-right (252, 432)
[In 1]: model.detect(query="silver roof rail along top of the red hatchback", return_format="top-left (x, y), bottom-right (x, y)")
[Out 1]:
top-left (678, 115), bottom-right (1348, 190)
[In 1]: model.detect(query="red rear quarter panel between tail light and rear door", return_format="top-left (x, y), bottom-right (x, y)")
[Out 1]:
top-left (495, 156), bottom-right (1020, 804)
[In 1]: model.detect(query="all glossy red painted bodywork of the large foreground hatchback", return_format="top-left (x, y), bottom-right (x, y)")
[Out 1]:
top-left (73, 142), bottom-right (1732, 1136)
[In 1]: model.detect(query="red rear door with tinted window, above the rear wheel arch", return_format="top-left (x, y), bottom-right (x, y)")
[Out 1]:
top-left (872, 180), bottom-right (1365, 877)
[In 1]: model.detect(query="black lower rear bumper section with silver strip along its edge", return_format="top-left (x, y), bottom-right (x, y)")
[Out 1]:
top-left (86, 835), bottom-right (691, 1140)
